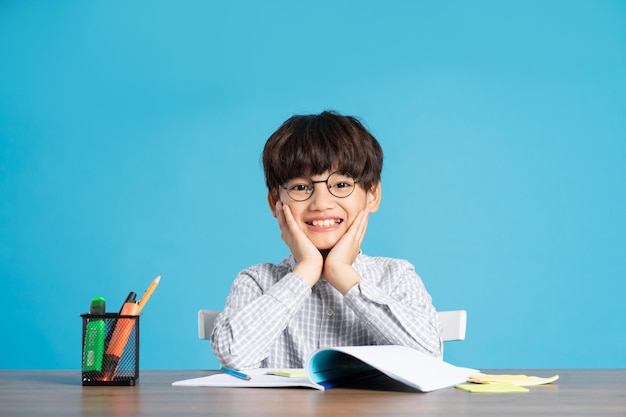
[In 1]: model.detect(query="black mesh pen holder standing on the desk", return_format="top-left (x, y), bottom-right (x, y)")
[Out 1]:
top-left (81, 313), bottom-right (139, 386)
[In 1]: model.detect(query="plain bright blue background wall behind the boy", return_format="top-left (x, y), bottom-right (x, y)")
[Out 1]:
top-left (0, 0), bottom-right (626, 369)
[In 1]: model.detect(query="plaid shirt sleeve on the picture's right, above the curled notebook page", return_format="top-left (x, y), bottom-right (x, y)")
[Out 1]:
top-left (345, 260), bottom-right (443, 357)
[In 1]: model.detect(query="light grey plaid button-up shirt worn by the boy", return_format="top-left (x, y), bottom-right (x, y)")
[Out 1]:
top-left (211, 254), bottom-right (443, 369)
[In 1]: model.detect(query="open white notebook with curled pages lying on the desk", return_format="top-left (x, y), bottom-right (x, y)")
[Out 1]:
top-left (172, 346), bottom-right (478, 392)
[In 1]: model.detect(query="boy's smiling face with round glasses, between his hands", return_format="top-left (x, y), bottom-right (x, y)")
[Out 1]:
top-left (268, 171), bottom-right (381, 251)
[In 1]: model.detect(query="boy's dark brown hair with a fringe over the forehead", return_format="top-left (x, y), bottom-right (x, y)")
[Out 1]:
top-left (263, 111), bottom-right (383, 193)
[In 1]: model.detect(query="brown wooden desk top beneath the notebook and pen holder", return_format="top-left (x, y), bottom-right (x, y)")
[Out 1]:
top-left (0, 369), bottom-right (626, 417)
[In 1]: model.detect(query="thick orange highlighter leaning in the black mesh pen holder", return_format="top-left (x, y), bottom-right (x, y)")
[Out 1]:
top-left (102, 291), bottom-right (139, 381)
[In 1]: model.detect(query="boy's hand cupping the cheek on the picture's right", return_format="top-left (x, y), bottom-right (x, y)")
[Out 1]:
top-left (323, 209), bottom-right (369, 295)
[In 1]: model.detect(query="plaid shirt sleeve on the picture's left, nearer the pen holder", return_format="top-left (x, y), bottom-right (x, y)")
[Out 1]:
top-left (211, 264), bottom-right (311, 369)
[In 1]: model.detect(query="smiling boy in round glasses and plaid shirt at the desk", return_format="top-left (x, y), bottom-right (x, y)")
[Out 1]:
top-left (211, 112), bottom-right (442, 369)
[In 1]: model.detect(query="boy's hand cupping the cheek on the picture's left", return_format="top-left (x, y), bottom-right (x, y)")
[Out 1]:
top-left (276, 201), bottom-right (324, 287)
